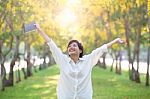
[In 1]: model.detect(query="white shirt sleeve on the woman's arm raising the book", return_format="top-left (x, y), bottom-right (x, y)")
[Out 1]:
top-left (47, 39), bottom-right (64, 66)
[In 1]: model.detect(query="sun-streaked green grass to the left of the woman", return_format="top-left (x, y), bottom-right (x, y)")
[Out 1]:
top-left (0, 67), bottom-right (58, 99)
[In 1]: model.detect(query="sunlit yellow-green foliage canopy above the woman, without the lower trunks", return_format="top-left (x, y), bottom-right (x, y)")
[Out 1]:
top-left (0, 0), bottom-right (148, 60)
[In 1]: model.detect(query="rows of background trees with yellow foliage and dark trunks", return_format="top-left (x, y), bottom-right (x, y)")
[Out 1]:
top-left (0, 0), bottom-right (149, 89)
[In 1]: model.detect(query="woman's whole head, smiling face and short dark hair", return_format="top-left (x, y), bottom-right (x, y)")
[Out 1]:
top-left (67, 40), bottom-right (83, 58)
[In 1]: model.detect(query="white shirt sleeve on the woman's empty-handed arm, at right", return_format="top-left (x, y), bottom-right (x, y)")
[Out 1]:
top-left (89, 44), bottom-right (108, 66)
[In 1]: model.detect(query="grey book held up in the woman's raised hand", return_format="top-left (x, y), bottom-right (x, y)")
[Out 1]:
top-left (24, 21), bottom-right (37, 33)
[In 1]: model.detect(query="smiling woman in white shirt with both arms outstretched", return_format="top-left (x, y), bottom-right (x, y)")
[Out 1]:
top-left (35, 24), bottom-right (124, 99)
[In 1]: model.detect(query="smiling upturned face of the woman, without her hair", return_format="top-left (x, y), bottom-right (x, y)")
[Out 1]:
top-left (67, 42), bottom-right (82, 56)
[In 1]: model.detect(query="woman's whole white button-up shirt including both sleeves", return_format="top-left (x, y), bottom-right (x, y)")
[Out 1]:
top-left (48, 40), bottom-right (107, 99)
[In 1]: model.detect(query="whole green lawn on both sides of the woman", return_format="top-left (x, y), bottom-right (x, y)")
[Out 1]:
top-left (0, 66), bottom-right (150, 99)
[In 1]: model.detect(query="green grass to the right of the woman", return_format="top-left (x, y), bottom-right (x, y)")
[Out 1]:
top-left (92, 68), bottom-right (150, 99)
